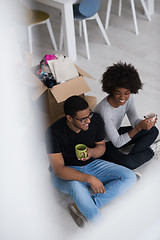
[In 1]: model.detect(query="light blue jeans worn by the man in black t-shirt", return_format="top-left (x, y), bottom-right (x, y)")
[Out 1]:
top-left (51, 159), bottom-right (136, 221)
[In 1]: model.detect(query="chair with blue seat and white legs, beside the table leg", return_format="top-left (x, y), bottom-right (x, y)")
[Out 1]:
top-left (59, 0), bottom-right (110, 59)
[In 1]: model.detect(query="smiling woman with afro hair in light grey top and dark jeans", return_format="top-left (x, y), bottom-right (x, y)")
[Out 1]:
top-left (95, 62), bottom-right (158, 169)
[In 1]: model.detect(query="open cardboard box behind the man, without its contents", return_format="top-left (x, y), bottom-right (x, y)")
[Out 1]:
top-left (27, 62), bottom-right (97, 125)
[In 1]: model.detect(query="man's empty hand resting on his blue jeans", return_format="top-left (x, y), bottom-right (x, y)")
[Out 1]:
top-left (88, 175), bottom-right (106, 193)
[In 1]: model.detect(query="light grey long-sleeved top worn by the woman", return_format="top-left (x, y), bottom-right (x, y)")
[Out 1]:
top-left (94, 94), bottom-right (141, 148)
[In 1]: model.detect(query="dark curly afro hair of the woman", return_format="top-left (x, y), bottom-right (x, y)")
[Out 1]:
top-left (101, 61), bottom-right (143, 95)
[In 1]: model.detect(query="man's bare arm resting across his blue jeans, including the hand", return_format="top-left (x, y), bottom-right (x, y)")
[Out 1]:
top-left (48, 153), bottom-right (105, 193)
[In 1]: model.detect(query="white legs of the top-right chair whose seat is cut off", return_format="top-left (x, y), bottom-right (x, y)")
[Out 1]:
top-left (105, 0), bottom-right (151, 35)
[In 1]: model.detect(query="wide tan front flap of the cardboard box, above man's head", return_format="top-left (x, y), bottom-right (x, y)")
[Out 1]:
top-left (50, 76), bottom-right (91, 103)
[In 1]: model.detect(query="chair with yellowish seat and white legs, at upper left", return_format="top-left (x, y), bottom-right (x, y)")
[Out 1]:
top-left (19, 0), bottom-right (57, 53)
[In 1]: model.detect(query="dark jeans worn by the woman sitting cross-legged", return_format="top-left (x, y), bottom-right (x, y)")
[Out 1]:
top-left (101, 126), bottom-right (158, 169)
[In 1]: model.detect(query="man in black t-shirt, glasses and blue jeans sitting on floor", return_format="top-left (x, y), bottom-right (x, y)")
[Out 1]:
top-left (46, 96), bottom-right (136, 227)
